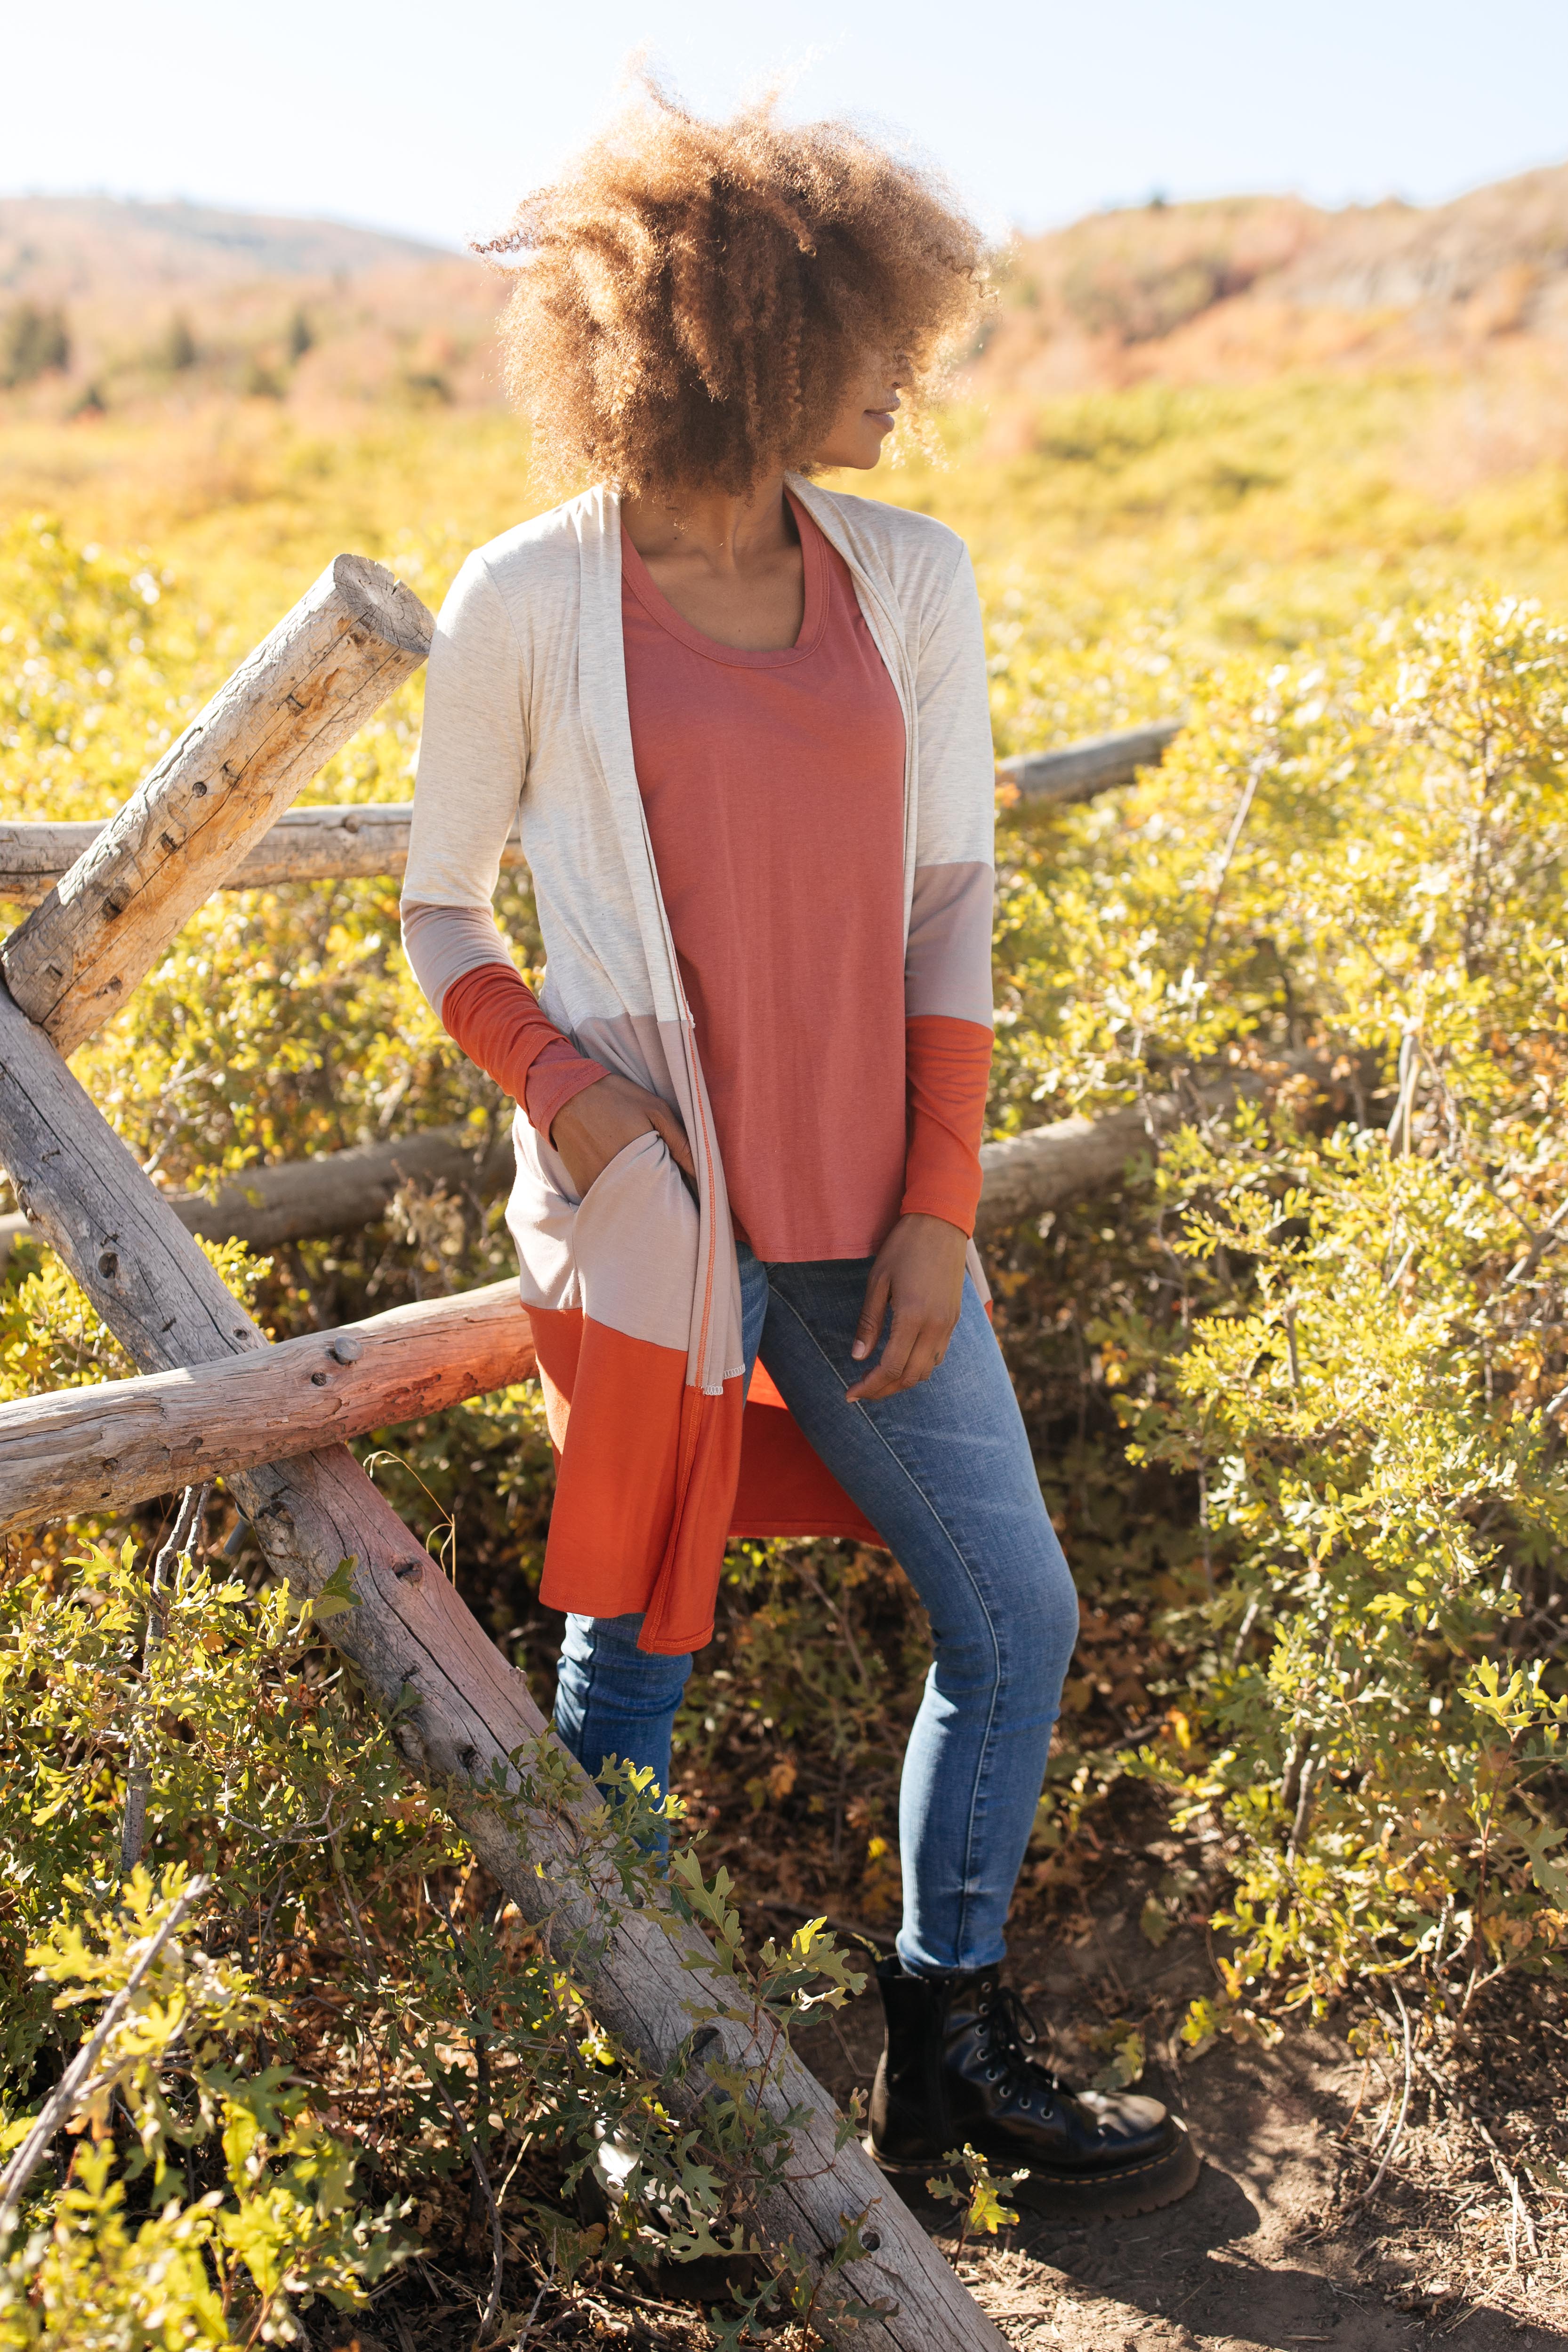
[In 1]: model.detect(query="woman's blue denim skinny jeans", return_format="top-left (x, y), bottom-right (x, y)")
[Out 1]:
top-left (555, 1246), bottom-right (1079, 1973)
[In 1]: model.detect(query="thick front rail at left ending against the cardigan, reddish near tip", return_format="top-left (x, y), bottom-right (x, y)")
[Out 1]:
top-left (0, 1282), bottom-right (534, 1536)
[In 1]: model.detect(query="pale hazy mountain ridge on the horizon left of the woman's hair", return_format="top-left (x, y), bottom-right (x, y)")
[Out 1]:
top-left (0, 195), bottom-right (451, 304)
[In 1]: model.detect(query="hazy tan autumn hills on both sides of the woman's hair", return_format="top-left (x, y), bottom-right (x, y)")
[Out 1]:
top-left (0, 165), bottom-right (1568, 435)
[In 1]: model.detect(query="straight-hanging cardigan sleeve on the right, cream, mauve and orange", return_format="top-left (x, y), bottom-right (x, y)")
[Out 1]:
top-left (901, 548), bottom-right (997, 1232)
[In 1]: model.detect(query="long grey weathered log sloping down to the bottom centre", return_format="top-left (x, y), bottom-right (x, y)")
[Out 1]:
top-left (0, 1011), bottom-right (1004, 2352)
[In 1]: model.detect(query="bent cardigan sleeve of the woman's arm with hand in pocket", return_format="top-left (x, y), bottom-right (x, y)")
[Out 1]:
top-left (402, 555), bottom-right (604, 1134)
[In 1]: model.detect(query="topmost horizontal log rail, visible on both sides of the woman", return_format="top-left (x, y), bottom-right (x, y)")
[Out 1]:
top-left (0, 720), bottom-right (1180, 906)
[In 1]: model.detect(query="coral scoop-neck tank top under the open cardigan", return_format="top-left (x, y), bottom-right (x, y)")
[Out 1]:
top-left (620, 498), bottom-right (907, 1260)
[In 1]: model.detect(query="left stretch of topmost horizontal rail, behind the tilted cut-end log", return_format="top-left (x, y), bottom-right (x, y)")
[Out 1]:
top-left (0, 800), bottom-right (524, 906)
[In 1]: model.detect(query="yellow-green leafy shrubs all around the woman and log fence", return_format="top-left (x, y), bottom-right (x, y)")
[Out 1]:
top-left (0, 386), bottom-right (1568, 2314)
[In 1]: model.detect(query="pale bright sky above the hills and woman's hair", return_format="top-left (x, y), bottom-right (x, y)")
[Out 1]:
top-left (0, 0), bottom-right (1568, 245)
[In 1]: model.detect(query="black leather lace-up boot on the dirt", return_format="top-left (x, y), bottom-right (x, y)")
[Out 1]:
top-left (868, 1959), bottom-right (1199, 2213)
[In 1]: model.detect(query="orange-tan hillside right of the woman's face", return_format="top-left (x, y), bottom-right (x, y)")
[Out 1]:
top-left (971, 165), bottom-right (1568, 395)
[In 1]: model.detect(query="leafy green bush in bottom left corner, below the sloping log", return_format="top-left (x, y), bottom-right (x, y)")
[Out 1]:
top-left (0, 1543), bottom-right (863, 2352)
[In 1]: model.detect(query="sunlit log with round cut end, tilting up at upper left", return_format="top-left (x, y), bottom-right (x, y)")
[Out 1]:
top-left (0, 555), bottom-right (435, 1054)
